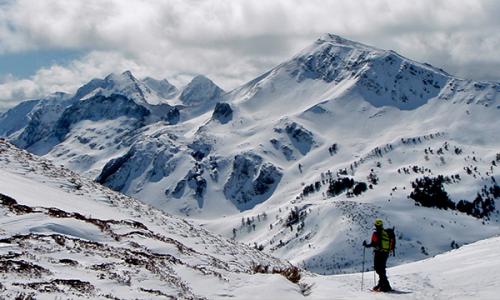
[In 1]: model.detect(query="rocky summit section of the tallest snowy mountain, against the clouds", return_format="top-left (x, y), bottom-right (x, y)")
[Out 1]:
top-left (231, 34), bottom-right (458, 110)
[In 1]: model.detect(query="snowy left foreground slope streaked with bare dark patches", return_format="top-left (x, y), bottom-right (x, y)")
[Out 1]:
top-left (0, 141), bottom-right (300, 299)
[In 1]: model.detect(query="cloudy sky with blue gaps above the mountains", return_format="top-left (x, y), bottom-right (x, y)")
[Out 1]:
top-left (0, 0), bottom-right (500, 110)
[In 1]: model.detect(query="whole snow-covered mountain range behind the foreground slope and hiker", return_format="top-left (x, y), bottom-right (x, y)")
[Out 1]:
top-left (0, 34), bottom-right (500, 273)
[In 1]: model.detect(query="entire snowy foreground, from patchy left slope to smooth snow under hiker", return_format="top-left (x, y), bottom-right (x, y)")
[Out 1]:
top-left (0, 140), bottom-right (500, 299)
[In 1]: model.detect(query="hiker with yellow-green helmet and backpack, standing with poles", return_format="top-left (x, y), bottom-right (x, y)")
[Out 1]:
top-left (363, 219), bottom-right (393, 292)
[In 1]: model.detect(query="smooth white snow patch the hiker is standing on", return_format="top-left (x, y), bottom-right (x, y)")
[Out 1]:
top-left (305, 237), bottom-right (500, 299)
